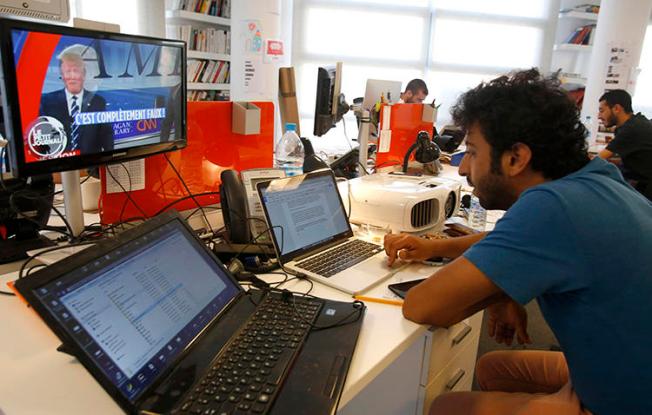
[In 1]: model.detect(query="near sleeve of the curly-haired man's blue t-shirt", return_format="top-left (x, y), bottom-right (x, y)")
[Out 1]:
top-left (464, 189), bottom-right (587, 304)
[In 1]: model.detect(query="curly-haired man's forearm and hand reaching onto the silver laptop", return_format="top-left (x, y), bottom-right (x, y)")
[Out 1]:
top-left (385, 232), bottom-right (487, 266)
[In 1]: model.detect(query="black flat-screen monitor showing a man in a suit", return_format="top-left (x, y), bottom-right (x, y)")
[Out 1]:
top-left (0, 19), bottom-right (186, 176)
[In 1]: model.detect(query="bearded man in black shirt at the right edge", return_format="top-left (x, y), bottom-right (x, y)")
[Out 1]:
top-left (598, 89), bottom-right (652, 200)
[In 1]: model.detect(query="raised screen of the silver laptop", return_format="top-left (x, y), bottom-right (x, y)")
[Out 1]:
top-left (258, 172), bottom-right (353, 262)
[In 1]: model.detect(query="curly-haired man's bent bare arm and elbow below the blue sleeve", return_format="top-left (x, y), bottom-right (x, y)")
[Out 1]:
top-left (403, 257), bottom-right (508, 327)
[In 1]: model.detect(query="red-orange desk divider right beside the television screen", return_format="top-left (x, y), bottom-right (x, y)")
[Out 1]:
top-left (99, 102), bottom-right (274, 224)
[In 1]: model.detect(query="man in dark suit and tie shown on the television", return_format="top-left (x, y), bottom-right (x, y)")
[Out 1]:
top-left (39, 51), bottom-right (113, 154)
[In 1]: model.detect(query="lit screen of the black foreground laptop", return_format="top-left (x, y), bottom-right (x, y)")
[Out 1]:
top-left (35, 220), bottom-right (239, 402)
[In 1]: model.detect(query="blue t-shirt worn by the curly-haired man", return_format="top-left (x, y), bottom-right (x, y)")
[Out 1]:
top-left (464, 158), bottom-right (652, 414)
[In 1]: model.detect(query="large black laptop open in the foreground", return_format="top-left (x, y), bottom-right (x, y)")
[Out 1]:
top-left (15, 213), bottom-right (365, 414)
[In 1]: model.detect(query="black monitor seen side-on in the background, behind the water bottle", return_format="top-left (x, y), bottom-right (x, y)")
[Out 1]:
top-left (313, 62), bottom-right (349, 137)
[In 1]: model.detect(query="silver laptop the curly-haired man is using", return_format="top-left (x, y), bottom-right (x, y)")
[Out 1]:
top-left (257, 170), bottom-right (394, 294)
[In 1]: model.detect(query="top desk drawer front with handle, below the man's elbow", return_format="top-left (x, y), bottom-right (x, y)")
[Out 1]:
top-left (424, 312), bottom-right (482, 384)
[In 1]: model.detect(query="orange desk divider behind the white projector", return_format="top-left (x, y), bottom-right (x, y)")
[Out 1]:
top-left (376, 104), bottom-right (433, 168)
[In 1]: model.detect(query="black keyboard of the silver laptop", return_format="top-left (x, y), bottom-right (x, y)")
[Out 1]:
top-left (297, 239), bottom-right (383, 277)
